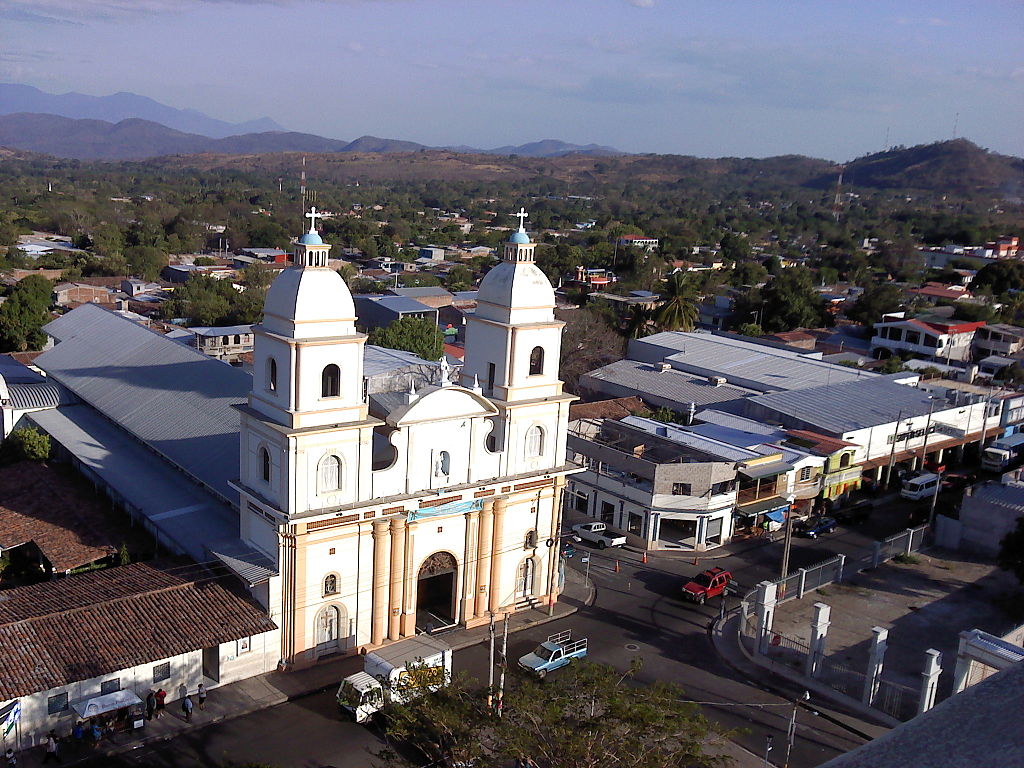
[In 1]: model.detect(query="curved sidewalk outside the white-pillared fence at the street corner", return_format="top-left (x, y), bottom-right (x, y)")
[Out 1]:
top-left (708, 610), bottom-right (890, 739)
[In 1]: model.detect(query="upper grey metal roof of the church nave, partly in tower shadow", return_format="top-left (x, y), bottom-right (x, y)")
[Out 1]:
top-left (36, 304), bottom-right (252, 504)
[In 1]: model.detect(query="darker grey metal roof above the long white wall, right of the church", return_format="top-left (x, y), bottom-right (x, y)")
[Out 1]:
top-left (750, 378), bottom-right (945, 435)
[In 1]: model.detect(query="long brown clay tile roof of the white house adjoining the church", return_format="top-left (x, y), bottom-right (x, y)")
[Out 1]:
top-left (0, 563), bottom-right (275, 699)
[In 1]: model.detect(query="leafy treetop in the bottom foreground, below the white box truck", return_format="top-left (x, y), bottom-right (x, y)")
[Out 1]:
top-left (379, 662), bottom-right (726, 768)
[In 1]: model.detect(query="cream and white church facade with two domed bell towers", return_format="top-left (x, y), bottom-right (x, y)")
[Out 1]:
top-left (234, 210), bottom-right (575, 665)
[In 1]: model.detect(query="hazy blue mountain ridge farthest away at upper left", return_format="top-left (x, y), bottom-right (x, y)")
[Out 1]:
top-left (0, 83), bottom-right (285, 138)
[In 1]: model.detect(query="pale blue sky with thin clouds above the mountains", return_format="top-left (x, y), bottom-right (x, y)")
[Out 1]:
top-left (0, 0), bottom-right (1024, 160)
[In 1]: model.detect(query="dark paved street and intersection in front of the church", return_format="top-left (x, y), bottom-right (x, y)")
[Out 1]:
top-left (90, 502), bottom-right (921, 768)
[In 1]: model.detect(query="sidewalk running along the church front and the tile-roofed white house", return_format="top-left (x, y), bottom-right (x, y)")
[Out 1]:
top-left (12, 568), bottom-right (595, 768)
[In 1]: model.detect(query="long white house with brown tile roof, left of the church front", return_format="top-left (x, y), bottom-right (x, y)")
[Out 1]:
top-left (0, 563), bottom-right (281, 749)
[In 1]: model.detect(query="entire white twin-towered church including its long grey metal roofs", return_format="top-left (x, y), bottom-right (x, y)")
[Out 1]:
top-left (16, 209), bottom-right (578, 667)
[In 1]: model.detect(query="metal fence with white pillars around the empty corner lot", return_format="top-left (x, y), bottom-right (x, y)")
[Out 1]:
top-left (738, 525), bottom-right (942, 725)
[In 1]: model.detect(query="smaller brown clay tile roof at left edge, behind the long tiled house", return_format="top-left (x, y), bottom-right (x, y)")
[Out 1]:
top-left (0, 462), bottom-right (117, 572)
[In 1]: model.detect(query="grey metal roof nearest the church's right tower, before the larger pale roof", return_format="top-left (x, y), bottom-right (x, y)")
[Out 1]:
top-left (581, 360), bottom-right (757, 408)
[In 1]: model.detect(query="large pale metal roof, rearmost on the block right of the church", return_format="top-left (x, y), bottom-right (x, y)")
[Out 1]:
top-left (629, 331), bottom-right (874, 392)
